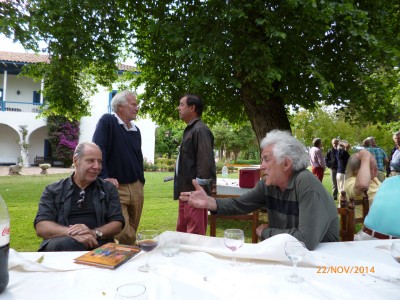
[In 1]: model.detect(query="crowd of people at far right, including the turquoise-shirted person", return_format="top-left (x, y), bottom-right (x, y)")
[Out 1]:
top-left (310, 131), bottom-right (400, 240)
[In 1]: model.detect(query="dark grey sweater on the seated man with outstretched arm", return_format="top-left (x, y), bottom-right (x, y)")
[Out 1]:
top-left (216, 170), bottom-right (339, 250)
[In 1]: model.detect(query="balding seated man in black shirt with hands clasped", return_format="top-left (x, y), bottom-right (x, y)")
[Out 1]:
top-left (34, 143), bottom-right (125, 251)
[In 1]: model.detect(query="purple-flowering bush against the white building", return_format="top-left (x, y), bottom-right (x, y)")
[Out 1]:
top-left (47, 116), bottom-right (79, 167)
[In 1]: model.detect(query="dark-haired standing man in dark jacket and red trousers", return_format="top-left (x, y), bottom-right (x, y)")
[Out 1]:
top-left (174, 94), bottom-right (217, 235)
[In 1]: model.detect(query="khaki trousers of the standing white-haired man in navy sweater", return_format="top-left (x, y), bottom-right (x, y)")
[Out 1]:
top-left (115, 180), bottom-right (144, 245)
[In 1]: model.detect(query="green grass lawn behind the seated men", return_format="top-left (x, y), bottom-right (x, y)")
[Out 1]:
top-left (0, 170), bottom-right (346, 251)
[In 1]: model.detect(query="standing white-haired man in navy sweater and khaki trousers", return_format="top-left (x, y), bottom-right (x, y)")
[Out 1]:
top-left (93, 90), bottom-right (145, 245)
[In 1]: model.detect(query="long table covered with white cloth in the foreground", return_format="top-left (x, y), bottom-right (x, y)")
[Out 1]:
top-left (0, 234), bottom-right (400, 300)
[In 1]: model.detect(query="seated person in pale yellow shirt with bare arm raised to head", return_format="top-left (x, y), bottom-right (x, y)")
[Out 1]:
top-left (345, 150), bottom-right (381, 206)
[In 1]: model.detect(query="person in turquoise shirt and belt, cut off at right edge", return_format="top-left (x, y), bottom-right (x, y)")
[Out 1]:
top-left (354, 176), bottom-right (400, 241)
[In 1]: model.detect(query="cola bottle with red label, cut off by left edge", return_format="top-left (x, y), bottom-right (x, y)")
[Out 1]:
top-left (0, 195), bottom-right (10, 294)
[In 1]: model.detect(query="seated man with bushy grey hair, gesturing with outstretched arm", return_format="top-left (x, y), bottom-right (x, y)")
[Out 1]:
top-left (179, 130), bottom-right (339, 250)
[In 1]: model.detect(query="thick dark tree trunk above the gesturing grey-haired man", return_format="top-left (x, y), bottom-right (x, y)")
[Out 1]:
top-left (242, 88), bottom-right (291, 144)
